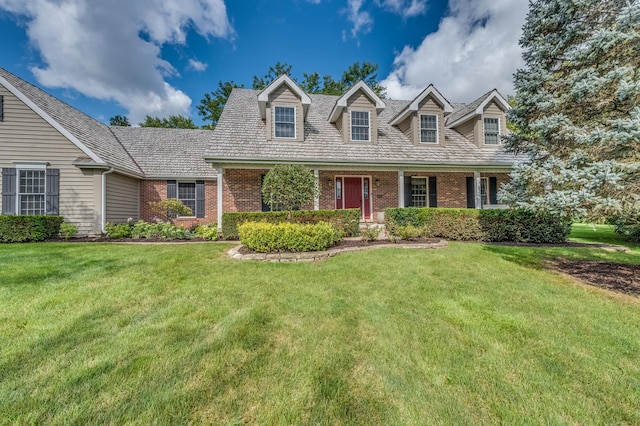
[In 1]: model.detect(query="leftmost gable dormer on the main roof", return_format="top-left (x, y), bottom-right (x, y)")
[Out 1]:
top-left (258, 74), bottom-right (311, 142)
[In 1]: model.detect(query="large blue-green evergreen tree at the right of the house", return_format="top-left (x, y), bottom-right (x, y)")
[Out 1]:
top-left (501, 0), bottom-right (640, 220)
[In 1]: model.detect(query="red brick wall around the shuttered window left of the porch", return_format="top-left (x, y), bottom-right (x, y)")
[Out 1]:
top-left (140, 180), bottom-right (218, 227)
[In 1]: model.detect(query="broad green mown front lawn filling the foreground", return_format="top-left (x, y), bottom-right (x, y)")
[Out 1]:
top-left (0, 238), bottom-right (640, 425)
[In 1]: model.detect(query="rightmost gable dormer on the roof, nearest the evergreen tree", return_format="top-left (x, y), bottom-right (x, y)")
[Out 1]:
top-left (447, 89), bottom-right (511, 148)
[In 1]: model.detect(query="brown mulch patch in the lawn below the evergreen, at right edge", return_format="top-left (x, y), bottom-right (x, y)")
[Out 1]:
top-left (551, 259), bottom-right (640, 296)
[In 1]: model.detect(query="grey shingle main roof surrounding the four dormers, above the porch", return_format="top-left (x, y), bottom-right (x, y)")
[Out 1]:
top-left (205, 89), bottom-right (516, 166)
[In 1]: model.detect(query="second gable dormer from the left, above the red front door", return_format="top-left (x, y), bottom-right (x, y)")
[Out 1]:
top-left (329, 80), bottom-right (386, 143)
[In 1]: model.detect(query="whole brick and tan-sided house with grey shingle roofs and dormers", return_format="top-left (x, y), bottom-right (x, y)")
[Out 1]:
top-left (0, 68), bottom-right (517, 234)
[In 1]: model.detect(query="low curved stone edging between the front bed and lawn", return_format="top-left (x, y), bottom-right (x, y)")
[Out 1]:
top-left (227, 240), bottom-right (447, 262)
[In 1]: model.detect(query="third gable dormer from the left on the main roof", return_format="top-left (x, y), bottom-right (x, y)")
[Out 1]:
top-left (390, 84), bottom-right (453, 145)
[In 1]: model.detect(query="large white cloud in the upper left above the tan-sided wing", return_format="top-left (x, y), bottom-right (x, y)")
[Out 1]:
top-left (0, 0), bottom-right (234, 123)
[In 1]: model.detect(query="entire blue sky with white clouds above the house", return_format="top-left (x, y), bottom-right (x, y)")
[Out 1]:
top-left (0, 0), bottom-right (528, 124)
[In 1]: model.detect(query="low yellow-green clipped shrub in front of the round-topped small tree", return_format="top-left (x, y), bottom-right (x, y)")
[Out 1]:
top-left (238, 222), bottom-right (336, 253)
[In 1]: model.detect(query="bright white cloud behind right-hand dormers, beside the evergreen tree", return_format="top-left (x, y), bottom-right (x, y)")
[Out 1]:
top-left (382, 0), bottom-right (528, 102)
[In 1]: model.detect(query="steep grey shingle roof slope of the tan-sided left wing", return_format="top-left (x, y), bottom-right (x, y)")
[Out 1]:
top-left (0, 68), bottom-right (142, 174)
